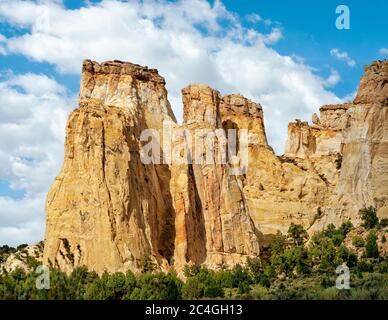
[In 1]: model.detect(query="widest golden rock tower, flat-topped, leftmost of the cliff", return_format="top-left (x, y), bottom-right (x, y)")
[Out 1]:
top-left (44, 60), bottom-right (175, 272)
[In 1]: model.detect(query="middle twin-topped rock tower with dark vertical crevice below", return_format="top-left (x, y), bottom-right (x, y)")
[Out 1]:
top-left (172, 85), bottom-right (260, 270)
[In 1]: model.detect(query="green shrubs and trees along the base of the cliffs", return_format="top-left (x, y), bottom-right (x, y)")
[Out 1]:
top-left (0, 209), bottom-right (388, 300)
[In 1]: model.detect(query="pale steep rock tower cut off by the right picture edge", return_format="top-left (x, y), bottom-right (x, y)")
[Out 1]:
top-left (314, 61), bottom-right (388, 229)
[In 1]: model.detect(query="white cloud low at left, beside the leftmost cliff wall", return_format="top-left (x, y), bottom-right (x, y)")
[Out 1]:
top-left (0, 73), bottom-right (76, 245)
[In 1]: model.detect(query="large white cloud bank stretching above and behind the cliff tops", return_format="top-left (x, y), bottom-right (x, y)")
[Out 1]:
top-left (0, 0), bottom-right (339, 148)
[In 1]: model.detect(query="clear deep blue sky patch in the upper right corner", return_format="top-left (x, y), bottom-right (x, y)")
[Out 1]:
top-left (224, 0), bottom-right (388, 96)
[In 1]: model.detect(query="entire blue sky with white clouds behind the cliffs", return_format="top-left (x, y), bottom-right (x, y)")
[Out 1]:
top-left (0, 0), bottom-right (388, 245)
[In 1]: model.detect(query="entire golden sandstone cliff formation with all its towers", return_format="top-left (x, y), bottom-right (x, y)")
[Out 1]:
top-left (44, 60), bottom-right (388, 272)
